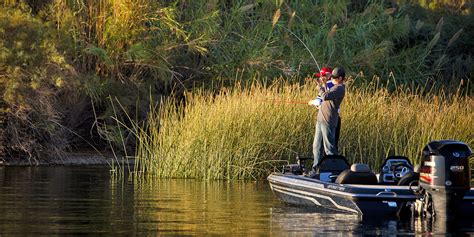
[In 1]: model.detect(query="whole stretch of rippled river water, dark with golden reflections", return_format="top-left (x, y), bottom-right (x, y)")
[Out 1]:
top-left (0, 167), bottom-right (474, 236)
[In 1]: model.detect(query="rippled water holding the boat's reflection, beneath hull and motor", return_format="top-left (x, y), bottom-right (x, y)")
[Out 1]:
top-left (270, 206), bottom-right (474, 236)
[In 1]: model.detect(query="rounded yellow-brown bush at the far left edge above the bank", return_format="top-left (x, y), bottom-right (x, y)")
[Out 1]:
top-left (0, 5), bottom-right (75, 158)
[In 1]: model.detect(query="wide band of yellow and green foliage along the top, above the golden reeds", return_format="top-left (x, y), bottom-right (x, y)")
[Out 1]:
top-left (4, 0), bottom-right (474, 88)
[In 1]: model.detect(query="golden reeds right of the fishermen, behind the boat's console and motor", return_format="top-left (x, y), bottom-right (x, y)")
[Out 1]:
top-left (341, 79), bottom-right (474, 168)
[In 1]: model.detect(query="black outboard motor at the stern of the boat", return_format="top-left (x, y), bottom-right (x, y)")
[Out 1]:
top-left (414, 140), bottom-right (472, 220)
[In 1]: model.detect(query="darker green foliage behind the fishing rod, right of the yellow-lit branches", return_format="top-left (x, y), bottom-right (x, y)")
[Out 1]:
top-left (164, 0), bottom-right (473, 85)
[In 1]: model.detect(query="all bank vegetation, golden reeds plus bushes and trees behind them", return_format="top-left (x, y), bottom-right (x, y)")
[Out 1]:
top-left (0, 0), bottom-right (474, 179)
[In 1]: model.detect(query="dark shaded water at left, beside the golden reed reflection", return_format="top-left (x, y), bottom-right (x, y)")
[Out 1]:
top-left (0, 167), bottom-right (134, 234)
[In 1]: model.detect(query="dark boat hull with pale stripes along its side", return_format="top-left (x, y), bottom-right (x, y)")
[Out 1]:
top-left (268, 173), bottom-right (417, 216)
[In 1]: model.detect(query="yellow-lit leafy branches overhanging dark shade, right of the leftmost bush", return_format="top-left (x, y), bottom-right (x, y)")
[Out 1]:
top-left (36, 0), bottom-right (218, 147)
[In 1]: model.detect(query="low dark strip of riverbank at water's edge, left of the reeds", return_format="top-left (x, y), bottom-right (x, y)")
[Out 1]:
top-left (0, 150), bottom-right (135, 166)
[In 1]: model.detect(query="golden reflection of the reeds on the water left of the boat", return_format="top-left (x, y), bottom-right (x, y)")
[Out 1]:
top-left (131, 180), bottom-right (277, 235)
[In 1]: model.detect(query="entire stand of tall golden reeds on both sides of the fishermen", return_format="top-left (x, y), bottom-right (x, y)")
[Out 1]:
top-left (131, 78), bottom-right (474, 179)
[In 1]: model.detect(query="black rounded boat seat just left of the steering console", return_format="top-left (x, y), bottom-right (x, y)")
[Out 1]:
top-left (336, 164), bottom-right (378, 185)
